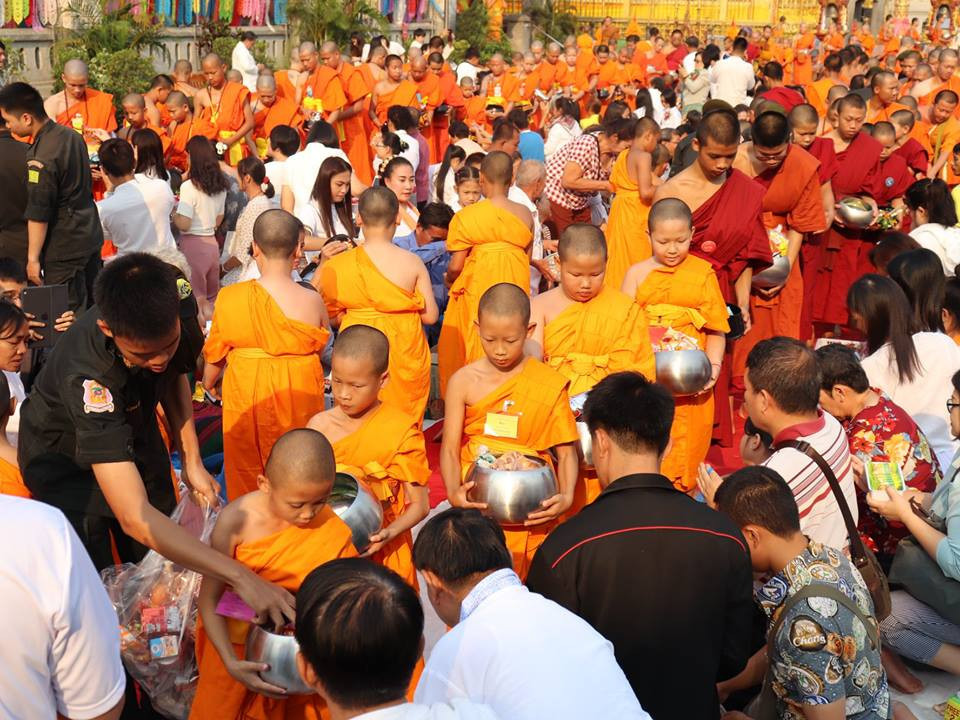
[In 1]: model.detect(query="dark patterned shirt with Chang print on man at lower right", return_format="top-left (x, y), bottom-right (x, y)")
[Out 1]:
top-left (756, 541), bottom-right (890, 720)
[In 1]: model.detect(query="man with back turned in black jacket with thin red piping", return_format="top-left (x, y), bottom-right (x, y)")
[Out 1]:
top-left (527, 372), bottom-right (752, 720)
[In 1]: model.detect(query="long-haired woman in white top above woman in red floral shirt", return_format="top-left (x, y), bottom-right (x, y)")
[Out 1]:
top-left (847, 275), bottom-right (960, 467)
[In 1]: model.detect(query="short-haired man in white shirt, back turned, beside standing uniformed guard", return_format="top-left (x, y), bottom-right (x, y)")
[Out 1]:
top-left (97, 138), bottom-right (176, 256)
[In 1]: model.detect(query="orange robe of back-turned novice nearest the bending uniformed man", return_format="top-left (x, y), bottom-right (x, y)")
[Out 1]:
top-left (203, 280), bottom-right (330, 500)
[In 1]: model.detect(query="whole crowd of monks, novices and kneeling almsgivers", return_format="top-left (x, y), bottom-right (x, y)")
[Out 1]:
top-left (7, 11), bottom-right (960, 720)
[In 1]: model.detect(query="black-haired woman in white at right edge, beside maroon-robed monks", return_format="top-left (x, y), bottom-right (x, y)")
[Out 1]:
top-left (903, 179), bottom-right (960, 275)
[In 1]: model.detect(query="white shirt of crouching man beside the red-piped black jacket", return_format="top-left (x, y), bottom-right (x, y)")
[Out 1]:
top-left (415, 570), bottom-right (650, 720)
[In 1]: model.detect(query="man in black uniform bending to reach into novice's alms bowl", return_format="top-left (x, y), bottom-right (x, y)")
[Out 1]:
top-left (18, 253), bottom-right (293, 624)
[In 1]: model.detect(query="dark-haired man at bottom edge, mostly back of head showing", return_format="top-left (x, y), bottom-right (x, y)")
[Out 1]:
top-left (294, 558), bottom-right (498, 720)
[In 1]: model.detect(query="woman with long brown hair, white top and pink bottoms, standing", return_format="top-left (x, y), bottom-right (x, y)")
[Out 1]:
top-left (173, 135), bottom-right (230, 318)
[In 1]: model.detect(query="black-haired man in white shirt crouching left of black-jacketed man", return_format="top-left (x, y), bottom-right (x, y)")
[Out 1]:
top-left (413, 508), bottom-right (650, 720)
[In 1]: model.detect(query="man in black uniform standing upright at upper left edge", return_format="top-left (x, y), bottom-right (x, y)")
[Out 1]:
top-left (0, 83), bottom-right (103, 311)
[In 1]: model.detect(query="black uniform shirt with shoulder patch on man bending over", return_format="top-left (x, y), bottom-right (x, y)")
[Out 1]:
top-left (18, 278), bottom-right (203, 517)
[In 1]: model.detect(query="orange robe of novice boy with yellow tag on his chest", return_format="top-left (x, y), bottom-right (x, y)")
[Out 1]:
top-left (460, 358), bottom-right (577, 579)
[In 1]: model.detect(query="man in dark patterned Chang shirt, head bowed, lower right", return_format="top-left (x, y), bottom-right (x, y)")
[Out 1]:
top-left (716, 466), bottom-right (890, 720)
